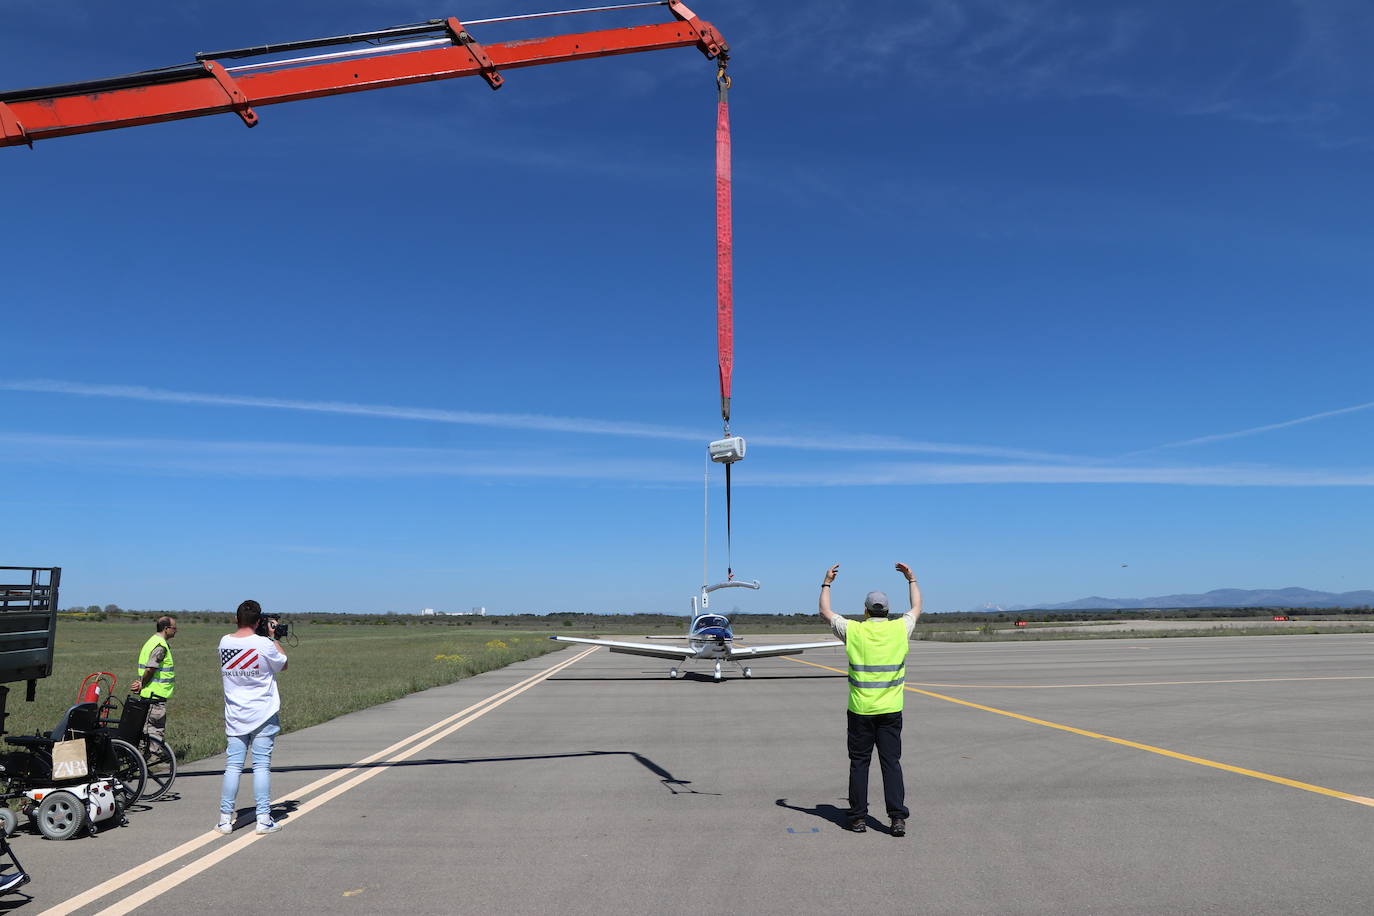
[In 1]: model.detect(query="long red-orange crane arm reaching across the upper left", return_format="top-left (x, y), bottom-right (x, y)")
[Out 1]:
top-left (0, 0), bottom-right (730, 147)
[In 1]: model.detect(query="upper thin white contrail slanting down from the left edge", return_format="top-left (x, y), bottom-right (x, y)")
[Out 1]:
top-left (0, 379), bottom-right (1083, 461)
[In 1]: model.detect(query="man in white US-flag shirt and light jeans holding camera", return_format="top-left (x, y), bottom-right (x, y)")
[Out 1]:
top-left (214, 600), bottom-right (286, 836)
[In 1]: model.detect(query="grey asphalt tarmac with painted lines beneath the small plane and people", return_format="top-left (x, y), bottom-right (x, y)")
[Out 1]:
top-left (10, 634), bottom-right (1374, 916)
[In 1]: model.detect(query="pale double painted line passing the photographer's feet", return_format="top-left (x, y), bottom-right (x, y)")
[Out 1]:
top-left (38, 647), bottom-right (596, 916)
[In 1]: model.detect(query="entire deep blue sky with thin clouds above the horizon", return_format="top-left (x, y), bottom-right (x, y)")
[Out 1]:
top-left (0, 0), bottom-right (1374, 611)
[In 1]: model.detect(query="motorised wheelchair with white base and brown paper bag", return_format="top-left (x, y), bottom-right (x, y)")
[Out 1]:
top-left (0, 703), bottom-right (148, 839)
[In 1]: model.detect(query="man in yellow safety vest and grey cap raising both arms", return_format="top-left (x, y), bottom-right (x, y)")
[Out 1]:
top-left (820, 563), bottom-right (921, 836)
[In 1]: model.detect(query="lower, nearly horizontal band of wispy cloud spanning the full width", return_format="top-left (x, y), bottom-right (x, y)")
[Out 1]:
top-left (0, 434), bottom-right (1374, 488)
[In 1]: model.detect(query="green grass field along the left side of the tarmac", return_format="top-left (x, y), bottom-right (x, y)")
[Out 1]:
top-left (5, 617), bottom-right (566, 759)
